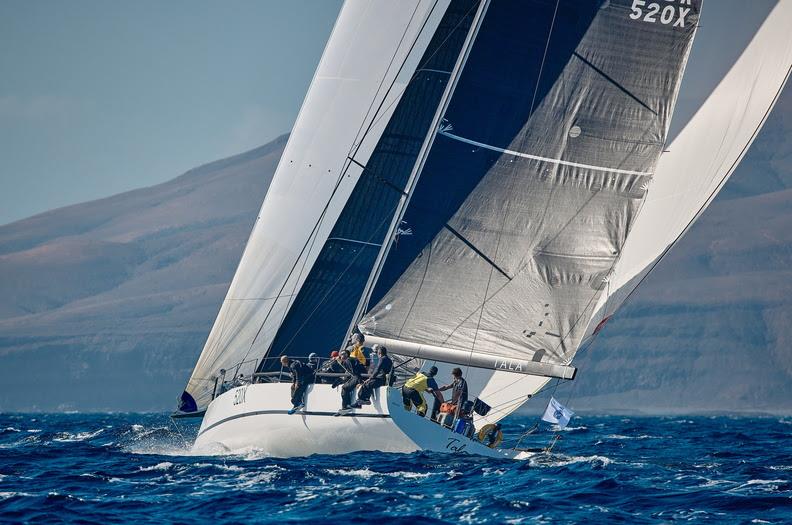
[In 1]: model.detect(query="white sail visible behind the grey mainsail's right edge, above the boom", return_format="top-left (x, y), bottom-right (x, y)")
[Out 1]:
top-left (587, 2), bottom-right (792, 344)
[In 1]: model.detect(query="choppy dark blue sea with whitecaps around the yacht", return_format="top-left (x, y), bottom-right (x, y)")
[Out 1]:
top-left (0, 414), bottom-right (792, 525)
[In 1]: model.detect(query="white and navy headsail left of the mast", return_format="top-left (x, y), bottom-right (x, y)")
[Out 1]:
top-left (182, 0), bottom-right (488, 411)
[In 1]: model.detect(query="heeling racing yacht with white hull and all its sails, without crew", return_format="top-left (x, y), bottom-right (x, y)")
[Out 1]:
top-left (173, 0), bottom-right (792, 459)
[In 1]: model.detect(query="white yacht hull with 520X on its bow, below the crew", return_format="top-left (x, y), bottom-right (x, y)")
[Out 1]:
top-left (193, 383), bottom-right (530, 459)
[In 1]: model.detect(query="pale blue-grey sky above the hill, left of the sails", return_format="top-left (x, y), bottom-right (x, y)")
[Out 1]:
top-left (0, 0), bottom-right (341, 224)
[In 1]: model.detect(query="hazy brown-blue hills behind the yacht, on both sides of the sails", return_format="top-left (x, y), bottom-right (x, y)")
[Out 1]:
top-left (0, 84), bottom-right (792, 412)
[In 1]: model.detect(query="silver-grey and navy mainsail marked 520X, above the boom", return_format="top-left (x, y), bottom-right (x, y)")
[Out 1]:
top-left (361, 1), bottom-right (699, 378)
